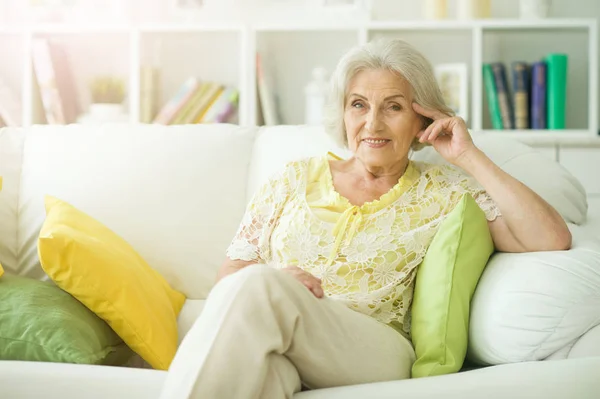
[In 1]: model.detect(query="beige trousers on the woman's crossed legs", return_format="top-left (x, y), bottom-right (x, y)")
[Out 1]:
top-left (161, 265), bottom-right (415, 399)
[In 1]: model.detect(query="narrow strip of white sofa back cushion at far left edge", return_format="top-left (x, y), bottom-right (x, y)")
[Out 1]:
top-left (0, 128), bottom-right (25, 273)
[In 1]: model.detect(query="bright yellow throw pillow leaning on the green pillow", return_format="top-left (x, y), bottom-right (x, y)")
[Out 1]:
top-left (38, 196), bottom-right (185, 370)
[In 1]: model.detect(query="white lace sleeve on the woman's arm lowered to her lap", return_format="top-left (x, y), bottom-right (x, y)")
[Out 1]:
top-left (227, 163), bottom-right (295, 263)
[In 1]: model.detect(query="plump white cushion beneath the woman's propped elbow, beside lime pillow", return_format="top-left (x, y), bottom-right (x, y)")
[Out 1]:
top-left (468, 233), bottom-right (600, 364)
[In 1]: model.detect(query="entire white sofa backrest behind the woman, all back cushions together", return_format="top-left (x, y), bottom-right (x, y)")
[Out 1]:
top-left (0, 125), bottom-right (586, 298)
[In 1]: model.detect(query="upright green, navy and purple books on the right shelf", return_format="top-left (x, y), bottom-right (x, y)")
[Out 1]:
top-left (483, 54), bottom-right (568, 129)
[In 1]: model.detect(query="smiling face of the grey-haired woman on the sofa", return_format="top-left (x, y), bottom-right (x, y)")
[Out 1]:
top-left (344, 69), bottom-right (423, 168)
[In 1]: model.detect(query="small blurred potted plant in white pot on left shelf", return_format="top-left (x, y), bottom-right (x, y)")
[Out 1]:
top-left (80, 76), bottom-right (127, 123)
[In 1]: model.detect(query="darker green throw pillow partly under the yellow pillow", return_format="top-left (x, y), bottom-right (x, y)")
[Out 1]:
top-left (0, 275), bottom-right (133, 365)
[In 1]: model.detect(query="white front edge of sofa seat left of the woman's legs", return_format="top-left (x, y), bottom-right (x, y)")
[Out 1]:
top-left (0, 361), bottom-right (167, 399)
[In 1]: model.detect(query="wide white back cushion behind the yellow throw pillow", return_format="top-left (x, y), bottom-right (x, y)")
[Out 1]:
top-left (18, 125), bottom-right (256, 299)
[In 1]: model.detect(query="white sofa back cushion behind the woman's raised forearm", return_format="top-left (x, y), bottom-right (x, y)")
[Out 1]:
top-left (413, 134), bottom-right (587, 224)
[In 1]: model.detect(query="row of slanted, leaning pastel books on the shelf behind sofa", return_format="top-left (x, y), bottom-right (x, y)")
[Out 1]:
top-left (153, 77), bottom-right (239, 125)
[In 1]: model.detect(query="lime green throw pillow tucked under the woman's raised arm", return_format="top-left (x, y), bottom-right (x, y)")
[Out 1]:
top-left (411, 194), bottom-right (494, 378)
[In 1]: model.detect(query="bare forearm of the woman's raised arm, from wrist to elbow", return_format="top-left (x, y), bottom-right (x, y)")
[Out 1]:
top-left (458, 148), bottom-right (571, 251)
